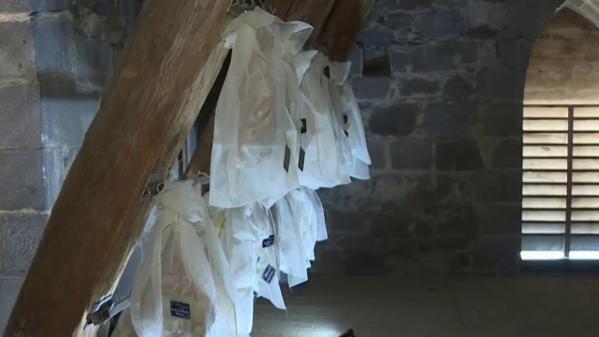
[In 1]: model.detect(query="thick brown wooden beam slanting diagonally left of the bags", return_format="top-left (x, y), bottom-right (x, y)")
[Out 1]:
top-left (4, 0), bottom-right (230, 337)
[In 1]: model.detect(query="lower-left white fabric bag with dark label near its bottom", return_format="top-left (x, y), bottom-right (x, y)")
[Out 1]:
top-left (130, 181), bottom-right (237, 337)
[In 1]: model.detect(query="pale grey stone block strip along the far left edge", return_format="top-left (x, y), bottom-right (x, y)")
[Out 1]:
top-left (0, 0), bottom-right (46, 331)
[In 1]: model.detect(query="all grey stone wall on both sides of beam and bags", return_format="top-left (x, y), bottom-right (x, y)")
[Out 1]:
top-left (0, 0), bottom-right (576, 328)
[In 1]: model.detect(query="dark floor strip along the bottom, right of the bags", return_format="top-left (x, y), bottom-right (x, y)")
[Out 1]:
top-left (253, 276), bottom-right (599, 337)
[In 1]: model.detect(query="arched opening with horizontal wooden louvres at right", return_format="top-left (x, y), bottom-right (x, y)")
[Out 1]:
top-left (521, 5), bottom-right (599, 260)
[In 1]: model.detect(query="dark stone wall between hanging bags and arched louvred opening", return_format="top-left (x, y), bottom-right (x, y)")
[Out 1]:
top-left (317, 0), bottom-right (561, 274)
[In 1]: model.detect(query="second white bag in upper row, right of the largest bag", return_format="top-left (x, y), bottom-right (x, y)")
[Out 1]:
top-left (297, 53), bottom-right (352, 190)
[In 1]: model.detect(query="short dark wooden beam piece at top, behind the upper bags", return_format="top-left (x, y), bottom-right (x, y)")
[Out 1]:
top-left (316, 0), bottom-right (376, 62)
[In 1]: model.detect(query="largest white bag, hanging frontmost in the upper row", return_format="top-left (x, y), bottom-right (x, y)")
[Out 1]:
top-left (210, 9), bottom-right (312, 208)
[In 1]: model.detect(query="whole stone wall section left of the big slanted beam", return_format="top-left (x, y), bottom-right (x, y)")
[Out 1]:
top-left (0, 0), bottom-right (140, 332)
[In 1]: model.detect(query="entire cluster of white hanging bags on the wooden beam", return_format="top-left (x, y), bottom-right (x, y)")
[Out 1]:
top-left (113, 9), bottom-right (370, 337)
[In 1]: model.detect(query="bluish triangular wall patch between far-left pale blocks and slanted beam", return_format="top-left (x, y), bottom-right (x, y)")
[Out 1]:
top-left (32, 0), bottom-right (142, 209)
